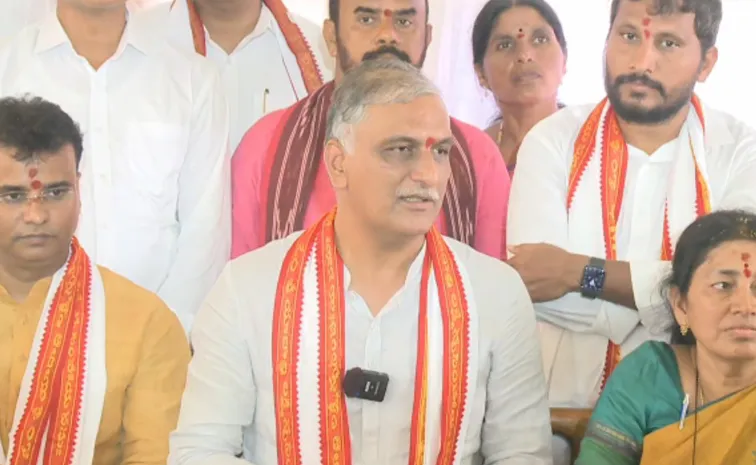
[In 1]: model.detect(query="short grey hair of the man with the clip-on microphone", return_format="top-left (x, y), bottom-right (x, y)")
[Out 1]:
top-left (326, 56), bottom-right (441, 150)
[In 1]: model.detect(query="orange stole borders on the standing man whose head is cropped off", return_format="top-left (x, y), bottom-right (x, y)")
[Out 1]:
top-left (185, 0), bottom-right (323, 94)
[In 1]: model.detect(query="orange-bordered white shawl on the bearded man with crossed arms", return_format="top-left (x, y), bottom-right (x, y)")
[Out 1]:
top-left (567, 96), bottom-right (711, 390)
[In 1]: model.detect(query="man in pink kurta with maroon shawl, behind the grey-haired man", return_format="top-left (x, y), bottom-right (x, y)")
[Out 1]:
top-left (232, 0), bottom-right (509, 258)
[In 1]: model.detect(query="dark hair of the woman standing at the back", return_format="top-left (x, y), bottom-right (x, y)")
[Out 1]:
top-left (472, 0), bottom-right (567, 65)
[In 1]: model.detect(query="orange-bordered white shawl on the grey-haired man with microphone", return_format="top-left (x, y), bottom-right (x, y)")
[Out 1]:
top-left (272, 212), bottom-right (478, 465)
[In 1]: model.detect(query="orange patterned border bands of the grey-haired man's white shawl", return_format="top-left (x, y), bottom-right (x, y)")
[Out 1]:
top-left (272, 211), bottom-right (470, 465)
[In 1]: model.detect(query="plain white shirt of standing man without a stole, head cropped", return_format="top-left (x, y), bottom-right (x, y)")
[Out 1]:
top-left (0, 13), bottom-right (231, 329)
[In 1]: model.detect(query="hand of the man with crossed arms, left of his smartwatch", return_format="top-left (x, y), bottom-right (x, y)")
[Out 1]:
top-left (507, 244), bottom-right (588, 303)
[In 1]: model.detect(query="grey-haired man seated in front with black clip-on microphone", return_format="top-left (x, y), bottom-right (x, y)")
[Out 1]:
top-left (168, 58), bottom-right (551, 465)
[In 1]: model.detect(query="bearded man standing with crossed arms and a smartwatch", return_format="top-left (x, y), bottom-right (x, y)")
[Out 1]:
top-left (507, 0), bottom-right (756, 407)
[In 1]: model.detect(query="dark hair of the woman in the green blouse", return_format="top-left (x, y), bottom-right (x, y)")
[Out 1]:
top-left (662, 210), bottom-right (756, 345)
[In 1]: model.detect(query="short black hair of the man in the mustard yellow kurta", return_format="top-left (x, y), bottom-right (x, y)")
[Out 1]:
top-left (0, 95), bottom-right (84, 169)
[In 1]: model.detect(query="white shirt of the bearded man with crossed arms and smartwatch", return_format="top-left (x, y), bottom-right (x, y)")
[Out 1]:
top-left (507, 101), bottom-right (756, 406)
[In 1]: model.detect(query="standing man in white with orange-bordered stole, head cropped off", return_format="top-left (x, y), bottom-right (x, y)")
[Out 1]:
top-left (144, 0), bottom-right (333, 150)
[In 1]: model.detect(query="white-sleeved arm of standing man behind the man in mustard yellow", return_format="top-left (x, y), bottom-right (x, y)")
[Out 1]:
top-left (158, 63), bottom-right (231, 331)
